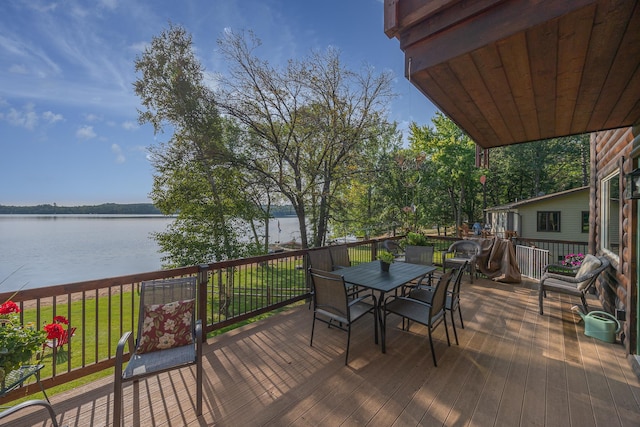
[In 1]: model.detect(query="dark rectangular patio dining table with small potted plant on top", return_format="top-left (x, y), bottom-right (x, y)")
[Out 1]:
top-left (334, 261), bottom-right (436, 353)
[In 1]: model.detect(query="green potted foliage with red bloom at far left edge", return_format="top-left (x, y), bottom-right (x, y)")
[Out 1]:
top-left (0, 301), bottom-right (45, 374)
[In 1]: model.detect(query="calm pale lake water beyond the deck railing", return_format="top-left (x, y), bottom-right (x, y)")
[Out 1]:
top-left (0, 215), bottom-right (300, 292)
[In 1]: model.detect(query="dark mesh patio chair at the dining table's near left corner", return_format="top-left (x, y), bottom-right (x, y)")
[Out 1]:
top-left (309, 268), bottom-right (378, 365)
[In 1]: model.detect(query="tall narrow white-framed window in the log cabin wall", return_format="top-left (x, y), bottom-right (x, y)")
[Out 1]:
top-left (600, 171), bottom-right (620, 257)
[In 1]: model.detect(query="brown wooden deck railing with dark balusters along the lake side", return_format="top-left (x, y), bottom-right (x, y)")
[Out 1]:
top-left (0, 237), bottom-right (392, 405)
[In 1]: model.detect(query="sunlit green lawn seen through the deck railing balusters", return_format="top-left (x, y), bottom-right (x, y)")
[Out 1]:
top-left (6, 262), bottom-right (306, 404)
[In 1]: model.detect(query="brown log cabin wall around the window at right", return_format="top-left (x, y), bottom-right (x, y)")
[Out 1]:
top-left (589, 127), bottom-right (640, 353)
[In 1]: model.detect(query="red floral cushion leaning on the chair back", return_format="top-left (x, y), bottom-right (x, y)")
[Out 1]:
top-left (136, 299), bottom-right (195, 354)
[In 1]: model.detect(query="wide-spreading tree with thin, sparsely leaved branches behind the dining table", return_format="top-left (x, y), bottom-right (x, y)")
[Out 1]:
top-left (218, 32), bottom-right (392, 247)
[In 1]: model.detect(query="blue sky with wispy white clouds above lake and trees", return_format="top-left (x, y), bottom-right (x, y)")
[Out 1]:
top-left (0, 0), bottom-right (435, 206)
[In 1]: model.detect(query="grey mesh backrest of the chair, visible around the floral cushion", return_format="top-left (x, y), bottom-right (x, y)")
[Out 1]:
top-left (136, 277), bottom-right (197, 350)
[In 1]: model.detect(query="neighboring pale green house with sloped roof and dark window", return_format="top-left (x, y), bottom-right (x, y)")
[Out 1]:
top-left (486, 187), bottom-right (589, 242)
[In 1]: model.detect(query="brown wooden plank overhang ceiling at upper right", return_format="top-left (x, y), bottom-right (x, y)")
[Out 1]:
top-left (384, 0), bottom-right (640, 148)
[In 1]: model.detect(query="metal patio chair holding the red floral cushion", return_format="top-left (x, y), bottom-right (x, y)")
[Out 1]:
top-left (113, 277), bottom-right (202, 427)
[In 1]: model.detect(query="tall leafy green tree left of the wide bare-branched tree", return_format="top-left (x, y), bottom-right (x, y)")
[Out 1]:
top-left (134, 25), bottom-right (262, 265)
